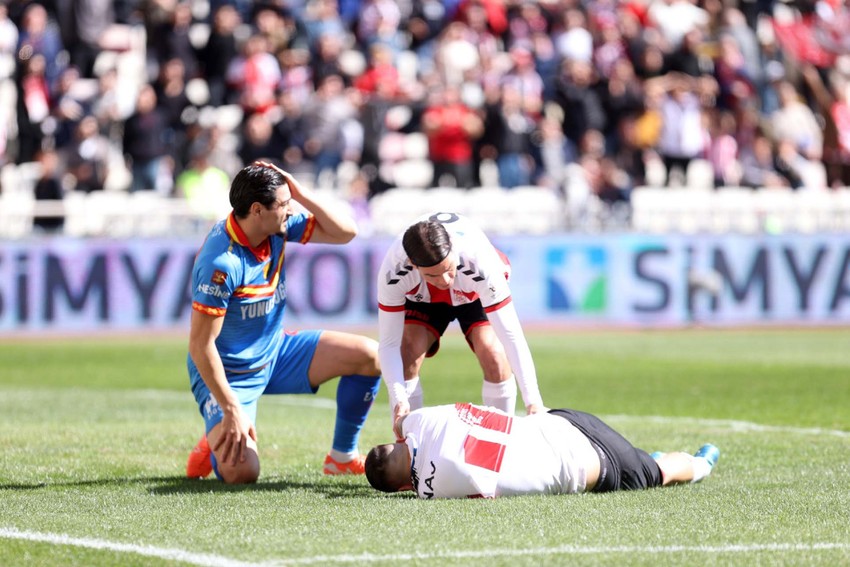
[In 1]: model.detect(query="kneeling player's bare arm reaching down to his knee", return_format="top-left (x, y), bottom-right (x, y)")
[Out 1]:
top-left (189, 310), bottom-right (257, 465)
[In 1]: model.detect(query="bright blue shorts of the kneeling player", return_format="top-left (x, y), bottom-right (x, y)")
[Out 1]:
top-left (187, 331), bottom-right (322, 433)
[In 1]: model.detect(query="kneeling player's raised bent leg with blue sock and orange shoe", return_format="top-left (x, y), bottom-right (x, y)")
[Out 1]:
top-left (308, 331), bottom-right (381, 474)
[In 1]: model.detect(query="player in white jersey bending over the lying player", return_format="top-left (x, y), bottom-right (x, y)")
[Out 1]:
top-left (378, 213), bottom-right (545, 435)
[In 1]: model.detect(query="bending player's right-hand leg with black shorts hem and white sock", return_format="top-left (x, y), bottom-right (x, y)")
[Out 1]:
top-left (455, 301), bottom-right (517, 414)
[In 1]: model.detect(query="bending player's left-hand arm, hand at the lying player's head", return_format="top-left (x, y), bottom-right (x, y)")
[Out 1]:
top-left (378, 305), bottom-right (410, 439)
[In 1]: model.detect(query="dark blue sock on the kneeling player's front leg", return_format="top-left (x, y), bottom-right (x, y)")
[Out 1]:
top-left (331, 374), bottom-right (381, 462)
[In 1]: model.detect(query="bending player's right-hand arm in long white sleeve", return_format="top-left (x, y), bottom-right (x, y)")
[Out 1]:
top-left (484, 298), bottom-right (546, 414)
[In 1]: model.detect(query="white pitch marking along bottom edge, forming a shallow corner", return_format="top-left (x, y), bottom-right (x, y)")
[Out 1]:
top-left (0, 528), bottom-right (850, 567)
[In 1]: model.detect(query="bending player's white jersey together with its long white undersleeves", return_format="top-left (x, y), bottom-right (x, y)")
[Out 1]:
top-left (377, 213), bottom-right (543, 408)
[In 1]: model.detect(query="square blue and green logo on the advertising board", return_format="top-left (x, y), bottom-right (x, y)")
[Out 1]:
top-left (546, 246), bottom-right (610, 314)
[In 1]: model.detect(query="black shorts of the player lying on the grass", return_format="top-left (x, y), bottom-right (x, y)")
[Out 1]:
top-left (549, 409), bottom-right (663, 492)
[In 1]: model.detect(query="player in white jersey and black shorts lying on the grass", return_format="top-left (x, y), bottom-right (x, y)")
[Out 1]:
top-left (366, 404), bottom-right (720, 498)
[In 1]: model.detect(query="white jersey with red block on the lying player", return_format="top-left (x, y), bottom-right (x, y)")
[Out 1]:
top-left (402, 404), bottom-right (598, 498)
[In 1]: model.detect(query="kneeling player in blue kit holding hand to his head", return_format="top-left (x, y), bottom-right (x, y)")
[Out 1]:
top-left (186, 162), bottom-right (380, 483)
